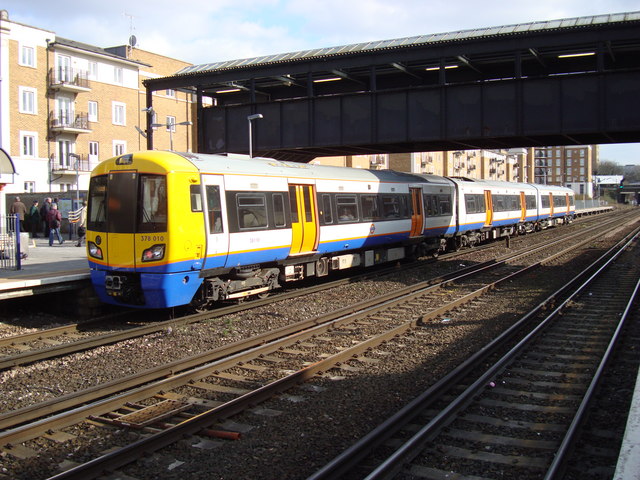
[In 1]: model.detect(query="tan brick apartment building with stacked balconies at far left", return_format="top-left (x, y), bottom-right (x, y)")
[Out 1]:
top-left (0, 10), bottom-right (197, 201)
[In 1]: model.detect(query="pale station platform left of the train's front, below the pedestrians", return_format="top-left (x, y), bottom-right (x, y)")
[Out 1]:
top-left (0, 234), bottom-right (90, 300)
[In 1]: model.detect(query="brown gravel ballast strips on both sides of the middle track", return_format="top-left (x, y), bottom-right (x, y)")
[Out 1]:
top-left (0, 214), bottom-right (636, 480)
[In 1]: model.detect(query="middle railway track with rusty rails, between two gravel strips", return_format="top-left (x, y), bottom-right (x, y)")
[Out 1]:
top-left (0, 212), bottom-right (636, 478)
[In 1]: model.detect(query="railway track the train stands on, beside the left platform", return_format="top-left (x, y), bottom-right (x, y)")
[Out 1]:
top-left (0, 212), bottom-right (634, 370)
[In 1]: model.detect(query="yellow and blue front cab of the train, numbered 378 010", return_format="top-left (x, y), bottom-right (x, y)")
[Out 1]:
top-left (87, 152), bottom-right (205, 308)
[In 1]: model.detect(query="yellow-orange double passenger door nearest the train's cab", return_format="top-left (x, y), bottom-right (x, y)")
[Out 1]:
top-left (289, 184), bottom-right (320, 255)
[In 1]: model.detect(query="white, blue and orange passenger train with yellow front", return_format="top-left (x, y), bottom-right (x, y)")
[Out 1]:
top-left (86, 150), bottom-right (575, 311)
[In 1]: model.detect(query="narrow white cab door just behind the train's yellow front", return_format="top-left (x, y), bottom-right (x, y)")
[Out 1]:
top-left (202, 175), bottom-right (229, 269)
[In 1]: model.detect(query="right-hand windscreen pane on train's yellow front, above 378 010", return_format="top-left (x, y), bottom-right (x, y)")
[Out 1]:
top-left (138, 175), bottom-right (167, 233)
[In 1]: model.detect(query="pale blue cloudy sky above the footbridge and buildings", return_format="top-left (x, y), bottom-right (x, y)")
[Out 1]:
top-left (5, 0), bottom-right (640, 165)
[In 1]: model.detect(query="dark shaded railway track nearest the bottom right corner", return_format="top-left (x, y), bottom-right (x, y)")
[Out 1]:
top-left (309, 225), bottom-right (640, 480)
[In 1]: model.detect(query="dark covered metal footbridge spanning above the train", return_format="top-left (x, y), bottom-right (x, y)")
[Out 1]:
top-left (144, 12), bottom-right (640, 161)
